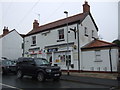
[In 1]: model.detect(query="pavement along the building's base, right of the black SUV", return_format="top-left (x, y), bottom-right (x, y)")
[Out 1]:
top-left (61, 72), bottom-right (120, 90)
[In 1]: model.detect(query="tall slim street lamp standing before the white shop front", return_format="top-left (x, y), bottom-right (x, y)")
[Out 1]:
top-left (64, 11), bottom-right (69, 75)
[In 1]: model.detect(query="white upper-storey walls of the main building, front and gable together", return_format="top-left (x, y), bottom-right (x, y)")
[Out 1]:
top-left (25, 15), bottom-right (98, 51)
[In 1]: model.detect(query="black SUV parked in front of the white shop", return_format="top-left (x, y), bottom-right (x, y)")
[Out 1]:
top-left (16, 57), bottom-right (61, 81)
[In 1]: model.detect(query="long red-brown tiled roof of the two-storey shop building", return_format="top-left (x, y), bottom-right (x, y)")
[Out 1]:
top-left (26, 12), bottom-right (96, 36)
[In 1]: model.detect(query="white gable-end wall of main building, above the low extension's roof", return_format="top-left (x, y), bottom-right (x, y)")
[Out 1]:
top-left (79, 15), bottom-right (98, 47)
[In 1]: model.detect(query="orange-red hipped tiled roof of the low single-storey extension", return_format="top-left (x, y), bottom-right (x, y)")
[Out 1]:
top-left (81, 40), bottom-right (116, 49)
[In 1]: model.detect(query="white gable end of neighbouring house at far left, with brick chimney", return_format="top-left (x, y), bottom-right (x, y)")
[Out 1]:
top-left (0, 27), bottom-right (23, 60)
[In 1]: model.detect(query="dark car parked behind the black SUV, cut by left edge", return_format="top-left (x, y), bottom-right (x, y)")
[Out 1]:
top-left (1, 59), bottom-right (16, 74)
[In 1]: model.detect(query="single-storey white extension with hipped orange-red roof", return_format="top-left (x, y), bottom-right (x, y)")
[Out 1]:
top-left (81, 40), bottom-right (119, 72)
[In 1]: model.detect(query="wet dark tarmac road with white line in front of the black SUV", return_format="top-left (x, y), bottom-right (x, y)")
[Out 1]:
top-left (0, 74), bottom-right (110, 90)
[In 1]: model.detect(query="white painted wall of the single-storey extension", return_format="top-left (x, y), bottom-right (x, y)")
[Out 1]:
top-left (82, 49), bottom-right (118, 71)
